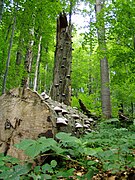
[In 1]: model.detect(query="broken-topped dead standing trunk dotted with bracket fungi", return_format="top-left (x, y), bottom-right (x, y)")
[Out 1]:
top-left (51, 12), bottom-right (72, 105)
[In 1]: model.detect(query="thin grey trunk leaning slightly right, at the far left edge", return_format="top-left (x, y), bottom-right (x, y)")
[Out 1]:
top-left (2, 17), bottom-right (16, 94)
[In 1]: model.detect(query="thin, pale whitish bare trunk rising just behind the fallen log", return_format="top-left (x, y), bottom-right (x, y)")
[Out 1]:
top-left (33, 36), bottom-right (42, 91)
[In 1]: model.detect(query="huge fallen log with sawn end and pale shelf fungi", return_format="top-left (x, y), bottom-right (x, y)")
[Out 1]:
top-left (0, 88), bottom-right (95, 159)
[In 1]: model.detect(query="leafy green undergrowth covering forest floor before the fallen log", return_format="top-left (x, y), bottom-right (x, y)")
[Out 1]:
top-left (0, 122), bottom-right (135, 180)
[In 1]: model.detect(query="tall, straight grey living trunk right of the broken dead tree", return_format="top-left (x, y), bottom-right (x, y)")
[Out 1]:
top-left (96, 0), bottom-right (111, 119)
